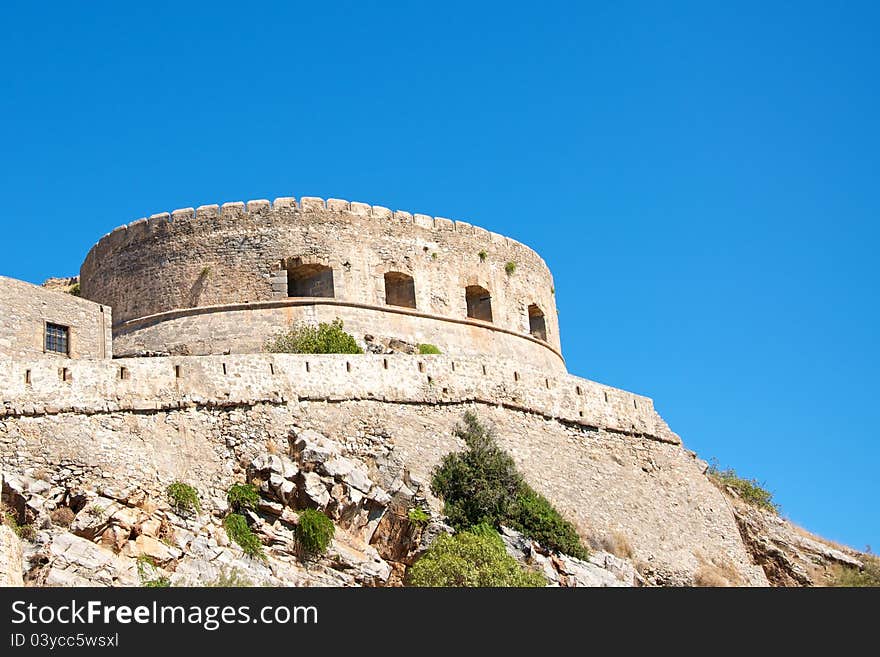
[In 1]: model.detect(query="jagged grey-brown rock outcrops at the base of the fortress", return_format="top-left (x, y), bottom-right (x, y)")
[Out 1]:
top-left (0, 428), bottom-right (644, 586)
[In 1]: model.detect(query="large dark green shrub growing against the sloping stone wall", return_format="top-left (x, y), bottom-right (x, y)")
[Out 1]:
top-left (431, 412), bottom-right (589, 559)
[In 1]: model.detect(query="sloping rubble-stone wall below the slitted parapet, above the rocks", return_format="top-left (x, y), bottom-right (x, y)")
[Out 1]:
top-left (0, 396), bottom-right (766, 584)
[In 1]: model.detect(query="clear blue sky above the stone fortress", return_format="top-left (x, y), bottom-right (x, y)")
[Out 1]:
top-left (0, 0), bottom-right (880, 549)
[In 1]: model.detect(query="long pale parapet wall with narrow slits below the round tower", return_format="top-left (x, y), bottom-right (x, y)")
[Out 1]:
top-left (0, 354), bottom-right (680, 443)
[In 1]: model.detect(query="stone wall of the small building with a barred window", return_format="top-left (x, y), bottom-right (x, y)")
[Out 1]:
top-left (0, 276), bottom-right (113, 367)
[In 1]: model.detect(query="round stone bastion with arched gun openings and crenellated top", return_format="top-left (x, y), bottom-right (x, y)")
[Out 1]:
top-left (80, 197), bottom-right (564, 370)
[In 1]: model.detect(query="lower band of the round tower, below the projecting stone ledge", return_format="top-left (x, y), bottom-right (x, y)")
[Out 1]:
top-left (113, 299), bottom-right (565, 372)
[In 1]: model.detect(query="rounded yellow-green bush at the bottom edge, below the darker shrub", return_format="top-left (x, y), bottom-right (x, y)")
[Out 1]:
top-left (407, 524), bottom-right (547, 587)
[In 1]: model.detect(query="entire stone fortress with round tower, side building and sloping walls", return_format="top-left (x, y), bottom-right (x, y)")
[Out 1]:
top-left (0, 197), bottom-right (766, 583)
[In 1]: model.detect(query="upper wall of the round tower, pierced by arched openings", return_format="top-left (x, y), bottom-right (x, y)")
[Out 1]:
top-left (80, 198), bottom-right (560, 353)
